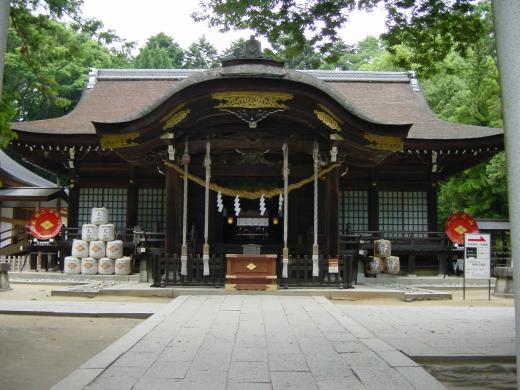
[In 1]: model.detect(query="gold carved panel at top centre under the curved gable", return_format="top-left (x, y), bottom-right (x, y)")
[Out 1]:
top-left (211, 91), bottom-right (294, 109)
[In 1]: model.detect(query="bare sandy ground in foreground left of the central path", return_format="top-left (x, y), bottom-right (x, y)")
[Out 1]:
top-left (0, 314), bottom-right (142, 390)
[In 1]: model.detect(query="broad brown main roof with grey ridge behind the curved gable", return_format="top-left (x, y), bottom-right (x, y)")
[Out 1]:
top-left (12, 65), bottom-right (503, 140)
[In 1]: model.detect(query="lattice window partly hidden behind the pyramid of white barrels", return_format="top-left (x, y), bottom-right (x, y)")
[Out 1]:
top-left (78, 187), bottom-right (127, 232)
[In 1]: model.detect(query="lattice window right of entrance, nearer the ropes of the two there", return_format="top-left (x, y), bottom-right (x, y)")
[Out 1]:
top-left (338, 190), bottom-right (368, 234)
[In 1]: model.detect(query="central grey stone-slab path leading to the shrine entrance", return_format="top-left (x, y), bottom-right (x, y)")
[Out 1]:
top-left (53, 295), bottom-right (443, 390)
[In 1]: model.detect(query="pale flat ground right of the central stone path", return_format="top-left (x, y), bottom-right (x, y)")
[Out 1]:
top-left (336, 304), bottom-right (516, 357)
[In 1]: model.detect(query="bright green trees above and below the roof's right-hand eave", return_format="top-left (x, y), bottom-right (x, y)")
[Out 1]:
top-left (421, 2), bottom-right (508, 224)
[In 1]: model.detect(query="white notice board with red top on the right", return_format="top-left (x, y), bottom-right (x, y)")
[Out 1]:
top-left (464, 233), bottom-right (491, 279)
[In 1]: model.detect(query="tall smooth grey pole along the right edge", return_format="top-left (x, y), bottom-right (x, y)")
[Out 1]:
top-left (492, 0), bottom-right (520, 378)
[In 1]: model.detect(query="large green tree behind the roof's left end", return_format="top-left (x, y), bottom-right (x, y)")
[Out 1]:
top-left (3, 20), bottom-right (130, 120)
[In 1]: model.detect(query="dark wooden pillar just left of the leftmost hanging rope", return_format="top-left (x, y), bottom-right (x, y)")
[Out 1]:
top-left (165, 165), bottom-right (182, 254)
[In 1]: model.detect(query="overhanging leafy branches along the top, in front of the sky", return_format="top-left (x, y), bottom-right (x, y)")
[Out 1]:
top-left (192, 0), bottom-right (483, 73)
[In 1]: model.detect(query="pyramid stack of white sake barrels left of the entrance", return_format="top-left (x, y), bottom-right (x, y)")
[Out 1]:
top-left (64, 207), bottom-right (131, 275)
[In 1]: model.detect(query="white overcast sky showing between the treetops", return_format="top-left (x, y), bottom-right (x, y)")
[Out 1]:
top-left (83, 0), bottom-right (385, 51)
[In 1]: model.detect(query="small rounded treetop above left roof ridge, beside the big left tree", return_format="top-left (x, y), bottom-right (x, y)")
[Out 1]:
top-left (134, 33), bottom-right (184, 69)
